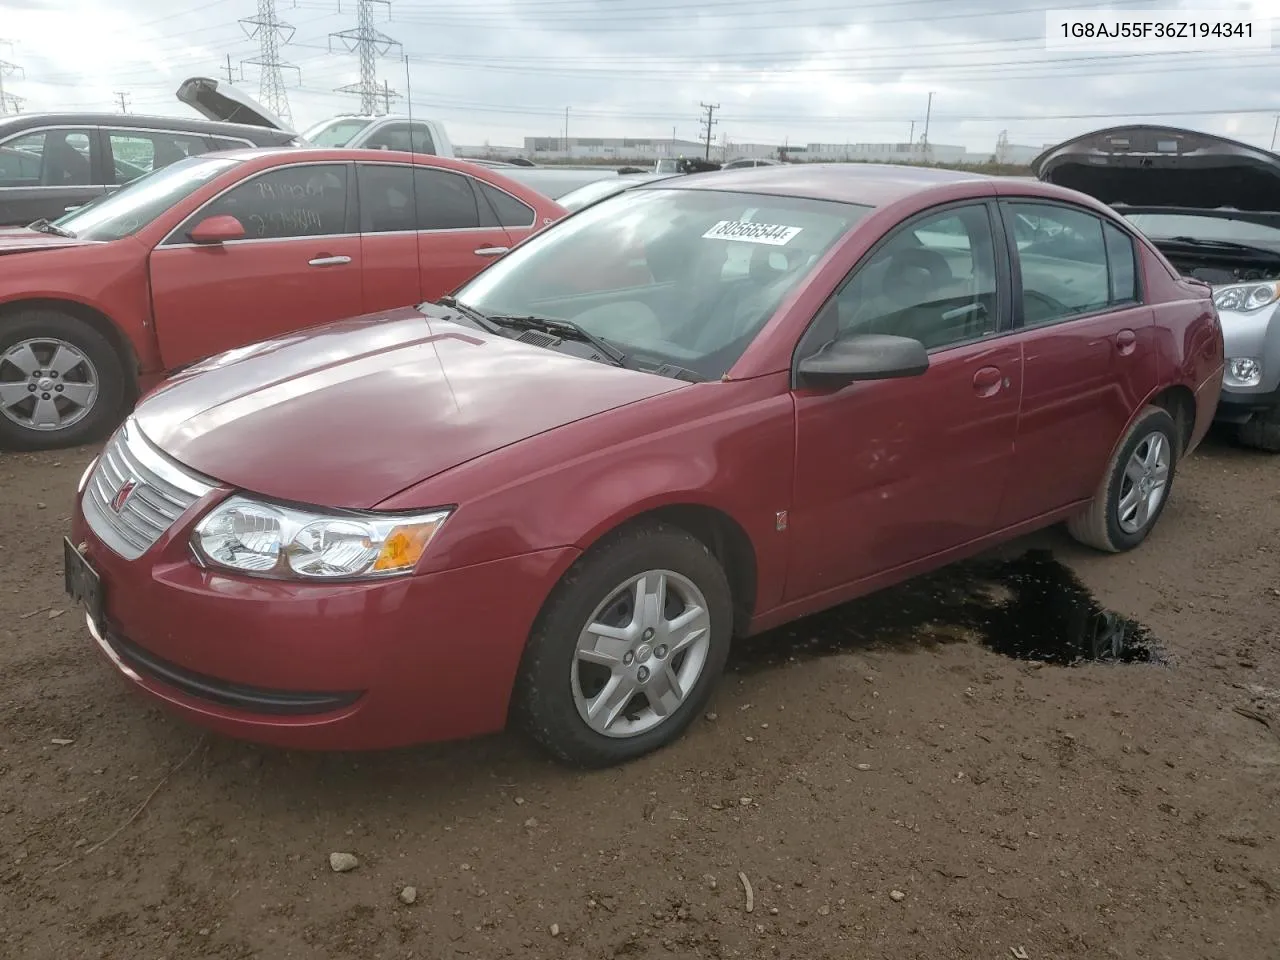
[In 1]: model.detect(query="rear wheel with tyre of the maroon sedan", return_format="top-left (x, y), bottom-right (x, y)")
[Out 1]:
top-left (1066, 407), bottom-right (1179, 553)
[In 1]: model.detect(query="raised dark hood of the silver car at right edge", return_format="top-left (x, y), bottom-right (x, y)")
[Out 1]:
top-left (1030, 125), bottom-right (1280, 212)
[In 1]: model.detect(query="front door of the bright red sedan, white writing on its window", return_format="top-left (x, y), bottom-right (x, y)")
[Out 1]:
top-left (151, 163), bottom-right (362, 369)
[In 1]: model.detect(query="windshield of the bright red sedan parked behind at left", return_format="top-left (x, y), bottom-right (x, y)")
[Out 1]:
top-left (54, 155), bottom-right (242, 241)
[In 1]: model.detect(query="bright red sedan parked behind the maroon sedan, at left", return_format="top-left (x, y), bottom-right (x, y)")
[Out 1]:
top-left (0, 148), bottom-right (564, 449)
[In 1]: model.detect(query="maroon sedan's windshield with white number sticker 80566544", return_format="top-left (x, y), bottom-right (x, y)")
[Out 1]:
top-left (457, 187), bottom-right (870, 379)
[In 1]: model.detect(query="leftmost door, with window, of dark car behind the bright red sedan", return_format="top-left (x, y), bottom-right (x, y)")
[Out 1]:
top-left (0, 127), bottom-right (106, 227)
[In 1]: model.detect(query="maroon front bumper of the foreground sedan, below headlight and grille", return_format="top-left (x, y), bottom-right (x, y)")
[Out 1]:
top-left (73, 511), bottom-right (577, 750)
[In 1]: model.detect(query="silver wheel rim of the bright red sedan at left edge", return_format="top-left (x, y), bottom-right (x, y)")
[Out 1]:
top-left (0, 338), bottom-right (99, 433)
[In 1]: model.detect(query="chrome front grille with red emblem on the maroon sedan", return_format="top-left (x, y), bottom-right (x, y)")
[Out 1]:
top-left (81, 417), bottom-right (215, 559)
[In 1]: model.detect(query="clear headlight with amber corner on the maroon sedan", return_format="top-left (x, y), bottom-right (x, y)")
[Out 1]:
top-left (191, 497), bottom-right (452, 580)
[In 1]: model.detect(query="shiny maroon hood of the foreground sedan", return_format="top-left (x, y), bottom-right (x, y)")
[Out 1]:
top-left (134, 308), bottom-right (687, 508)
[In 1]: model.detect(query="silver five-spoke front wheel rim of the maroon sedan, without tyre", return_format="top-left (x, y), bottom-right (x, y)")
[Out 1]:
top-left (571, 570), bottom-right (712, 737)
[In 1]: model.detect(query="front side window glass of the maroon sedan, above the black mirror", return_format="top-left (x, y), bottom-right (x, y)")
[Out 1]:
top-left (836, 204), bottom-right (997, 349)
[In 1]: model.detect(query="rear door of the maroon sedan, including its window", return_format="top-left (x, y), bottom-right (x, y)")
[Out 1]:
top-left (1000, 200), bottom-right (1158, 526)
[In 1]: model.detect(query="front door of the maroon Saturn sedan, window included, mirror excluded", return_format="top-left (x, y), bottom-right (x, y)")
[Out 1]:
top-left (786, 202), bottom-right (1023, 600)
